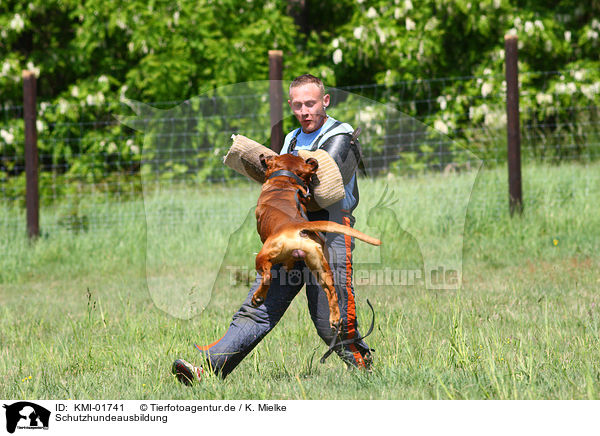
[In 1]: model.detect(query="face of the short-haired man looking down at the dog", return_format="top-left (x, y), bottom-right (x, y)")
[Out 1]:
top-left (288, 83), bottom-right (329, 133)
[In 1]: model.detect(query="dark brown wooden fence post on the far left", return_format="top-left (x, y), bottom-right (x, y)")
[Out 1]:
top-left (23, 71), bottom-right (40, 239)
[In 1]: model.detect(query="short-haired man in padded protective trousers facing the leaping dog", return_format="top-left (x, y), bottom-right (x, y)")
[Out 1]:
top-left (172, 74), bottom-right (372, 384)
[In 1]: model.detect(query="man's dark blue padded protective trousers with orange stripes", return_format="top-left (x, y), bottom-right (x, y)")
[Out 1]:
top-left (196, 216), bottom-right (370, 377)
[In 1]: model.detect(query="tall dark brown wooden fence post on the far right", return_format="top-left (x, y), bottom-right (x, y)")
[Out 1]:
top-left (504, 35), bottom-right (523, 216)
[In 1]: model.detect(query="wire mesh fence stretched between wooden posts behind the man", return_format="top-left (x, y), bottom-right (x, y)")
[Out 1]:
top-left (0, 70), bottom-right (600, 235)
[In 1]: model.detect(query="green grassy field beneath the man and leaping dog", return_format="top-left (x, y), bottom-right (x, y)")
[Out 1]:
top-left (0, 164), bottom-right (600, 399)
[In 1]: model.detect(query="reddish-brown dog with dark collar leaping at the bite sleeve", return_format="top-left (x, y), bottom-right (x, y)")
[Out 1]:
top-left (252, 154), bottom-right (381, 330)
